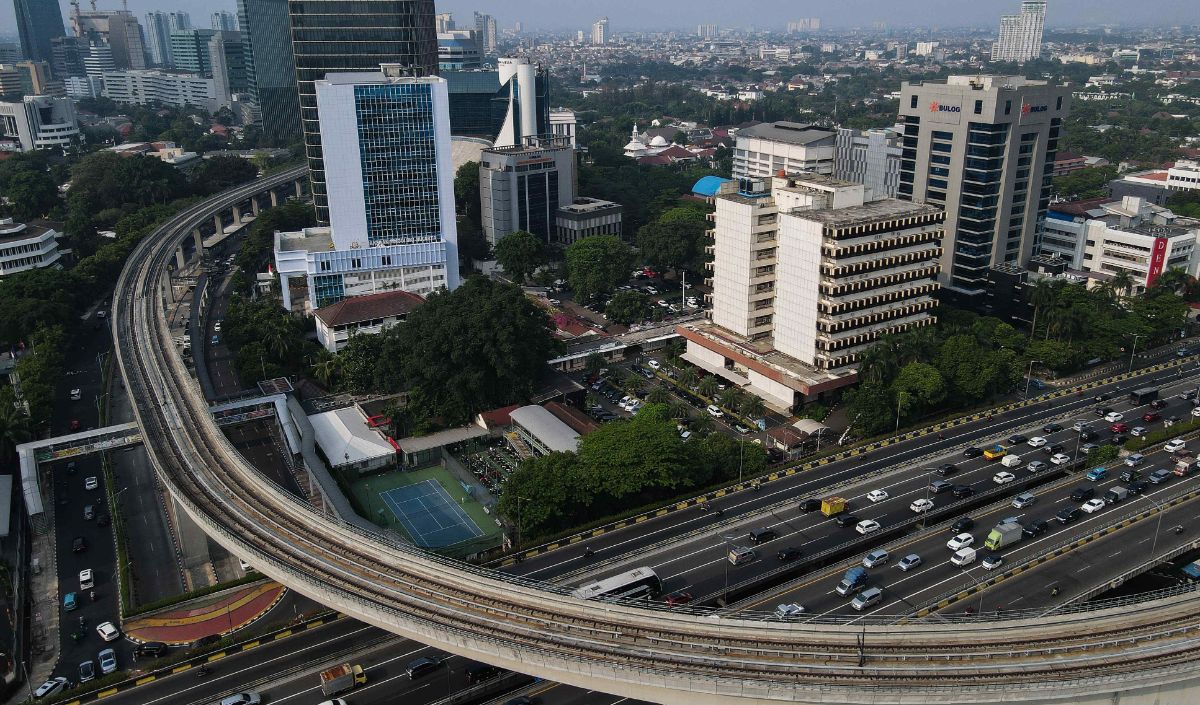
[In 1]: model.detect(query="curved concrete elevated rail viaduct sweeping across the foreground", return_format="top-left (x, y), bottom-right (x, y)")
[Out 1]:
top-left (113, 169), bottom-right (1200, 705)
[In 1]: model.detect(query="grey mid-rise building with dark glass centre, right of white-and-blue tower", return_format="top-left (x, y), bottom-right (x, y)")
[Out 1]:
top-left (479, 137), bottom-right (575, 245)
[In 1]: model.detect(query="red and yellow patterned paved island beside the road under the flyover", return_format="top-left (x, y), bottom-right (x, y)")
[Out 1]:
top-left (125, 580), bottom-right (287, 644)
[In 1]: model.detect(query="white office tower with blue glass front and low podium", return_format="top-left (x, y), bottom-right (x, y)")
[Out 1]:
top-left (275, 64), bottom-right (458, 312)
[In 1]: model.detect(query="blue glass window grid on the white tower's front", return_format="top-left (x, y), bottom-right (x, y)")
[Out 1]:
top-left (354, 84), bottom-right (442, 245)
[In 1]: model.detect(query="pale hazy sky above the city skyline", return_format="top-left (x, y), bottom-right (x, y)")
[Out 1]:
top-left (0, 0), bottom-right (1200, 44)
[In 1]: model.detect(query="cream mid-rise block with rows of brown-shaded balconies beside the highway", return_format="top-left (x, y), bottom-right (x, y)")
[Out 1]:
top-left (677, 174), bottom-right (944, 409)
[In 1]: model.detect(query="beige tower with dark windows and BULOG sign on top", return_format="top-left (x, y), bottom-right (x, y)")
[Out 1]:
top-left (896, 76), bottom-right (1070, 299)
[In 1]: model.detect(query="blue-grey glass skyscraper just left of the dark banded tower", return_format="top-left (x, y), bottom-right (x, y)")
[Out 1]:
top-left (238, 0), bottom-right (300, 145)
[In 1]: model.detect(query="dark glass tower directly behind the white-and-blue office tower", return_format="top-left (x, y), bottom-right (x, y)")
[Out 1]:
top-left (288, 0), bottom-right (438, 223)
